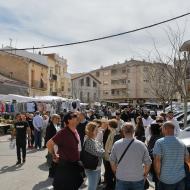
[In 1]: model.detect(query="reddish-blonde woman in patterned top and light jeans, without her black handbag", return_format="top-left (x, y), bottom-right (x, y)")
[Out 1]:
top-left (83, 122), bottom-right (104, 190)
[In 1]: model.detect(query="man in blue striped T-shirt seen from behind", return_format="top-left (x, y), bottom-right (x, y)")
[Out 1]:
top-left (153, 121), bottom-right (189, 190)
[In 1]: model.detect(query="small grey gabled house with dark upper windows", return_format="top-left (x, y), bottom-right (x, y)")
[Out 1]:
top-left (72, 73), bottom-right (100, 104)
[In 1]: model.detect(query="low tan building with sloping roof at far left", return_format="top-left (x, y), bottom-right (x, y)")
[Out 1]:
top-left (0, 47), bottom-right (48, 96)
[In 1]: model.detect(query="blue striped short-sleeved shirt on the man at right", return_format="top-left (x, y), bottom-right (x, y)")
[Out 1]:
top-left (153, 136), bottom-right (189, 184)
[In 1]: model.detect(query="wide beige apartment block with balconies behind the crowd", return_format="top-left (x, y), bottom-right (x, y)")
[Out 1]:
top-left (90, 59), bottom-right (157, 104)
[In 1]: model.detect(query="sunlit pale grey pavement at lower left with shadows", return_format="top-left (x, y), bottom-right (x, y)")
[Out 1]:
top-left (0, 135), bottom-right (153, 190)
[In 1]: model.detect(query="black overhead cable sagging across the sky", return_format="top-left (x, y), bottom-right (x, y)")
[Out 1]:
top-left (3, 13), bottom-right (190, 51)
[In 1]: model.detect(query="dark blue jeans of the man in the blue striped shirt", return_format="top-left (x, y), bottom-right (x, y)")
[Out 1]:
top-left (159, 179), bottom-right (185, 190)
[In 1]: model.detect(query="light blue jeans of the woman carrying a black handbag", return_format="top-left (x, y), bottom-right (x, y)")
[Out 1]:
top-left (85, 170), bottom-right (101, 190)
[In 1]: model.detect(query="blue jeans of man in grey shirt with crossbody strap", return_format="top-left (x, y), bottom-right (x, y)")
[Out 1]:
top-left (115, 179), bottom-right (144, 190)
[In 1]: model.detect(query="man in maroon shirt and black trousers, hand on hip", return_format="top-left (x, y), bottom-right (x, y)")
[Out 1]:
top-left (47, 112), bottom-right (83, 190)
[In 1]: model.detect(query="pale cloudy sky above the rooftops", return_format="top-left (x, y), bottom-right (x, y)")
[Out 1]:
top-left (0, 0), bottom-right (190, 72)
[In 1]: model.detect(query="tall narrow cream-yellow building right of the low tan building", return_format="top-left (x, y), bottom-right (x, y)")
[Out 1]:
top-left (44, 53), bottom-right (71, 98)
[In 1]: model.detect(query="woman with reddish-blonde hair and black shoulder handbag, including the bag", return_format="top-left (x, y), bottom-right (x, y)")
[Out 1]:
top-left (82, 122), bottom-right (104, 190)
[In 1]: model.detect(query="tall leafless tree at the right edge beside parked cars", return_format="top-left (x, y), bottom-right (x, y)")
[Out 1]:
top-left (155, 27), bottom-right (190, 127)
